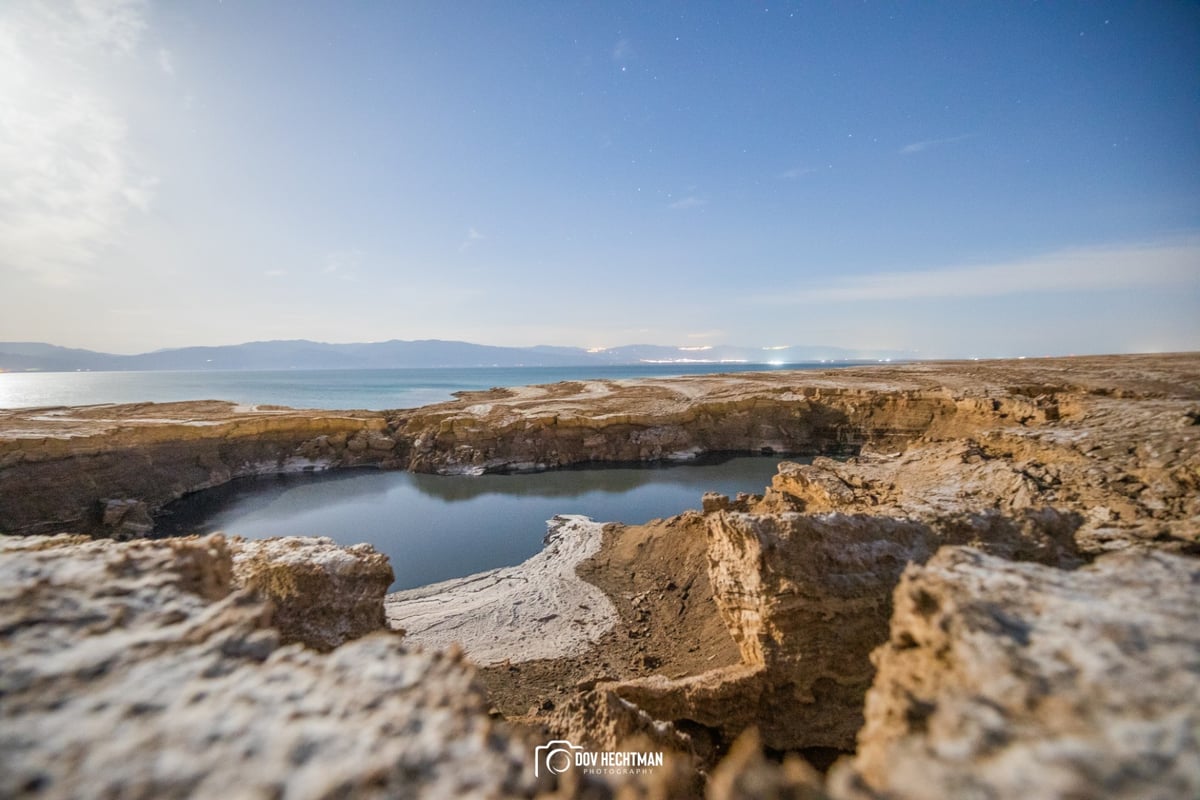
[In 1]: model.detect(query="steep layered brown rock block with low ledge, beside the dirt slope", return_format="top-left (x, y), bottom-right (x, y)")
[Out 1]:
top-left (600, 510), bottom-right (1078, 750)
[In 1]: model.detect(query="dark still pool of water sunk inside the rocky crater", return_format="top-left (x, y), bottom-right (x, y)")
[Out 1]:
top-left (157, 456), bottom-right (779, 591)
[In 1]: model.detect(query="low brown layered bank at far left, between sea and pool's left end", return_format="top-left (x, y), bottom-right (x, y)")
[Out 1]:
top-left (0, 401), bottom-right (398, 537)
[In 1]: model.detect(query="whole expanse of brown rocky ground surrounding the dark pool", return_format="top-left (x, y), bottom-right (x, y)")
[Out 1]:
top-left (0, 354), bottom-right (1200, 800)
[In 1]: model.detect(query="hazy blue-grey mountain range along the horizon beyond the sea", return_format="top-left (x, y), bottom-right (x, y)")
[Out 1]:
top-left (0, 339), bottom-right (913, 372)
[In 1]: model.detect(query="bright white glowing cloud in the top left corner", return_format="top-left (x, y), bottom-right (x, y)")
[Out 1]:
top-left (0, 0), bottom-right (157, 285)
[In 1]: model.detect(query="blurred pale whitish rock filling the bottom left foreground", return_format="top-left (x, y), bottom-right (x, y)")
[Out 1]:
top-left (0, 536), bottom-right (549, 799)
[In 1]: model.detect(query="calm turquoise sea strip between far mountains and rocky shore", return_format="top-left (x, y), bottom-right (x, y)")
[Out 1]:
top-left (0, 363), bottom-right (839, 410)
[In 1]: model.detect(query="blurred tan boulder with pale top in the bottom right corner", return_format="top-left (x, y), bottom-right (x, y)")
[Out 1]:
top-left (829, 547), bottom-right (1200, 800)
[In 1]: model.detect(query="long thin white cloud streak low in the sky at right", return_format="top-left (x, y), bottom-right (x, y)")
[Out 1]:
top-left (761, 240), bottom-right (1200, 305)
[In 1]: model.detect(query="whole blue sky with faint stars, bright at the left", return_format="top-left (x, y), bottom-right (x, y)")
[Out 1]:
top-left (0, 0), bottom-right (1200, 357)
